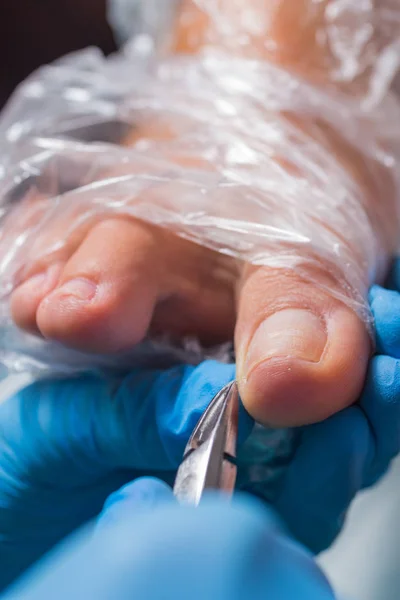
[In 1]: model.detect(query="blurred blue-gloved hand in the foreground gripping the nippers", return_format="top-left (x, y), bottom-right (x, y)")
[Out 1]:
top-left (1, 480), bottom-right (334, 600)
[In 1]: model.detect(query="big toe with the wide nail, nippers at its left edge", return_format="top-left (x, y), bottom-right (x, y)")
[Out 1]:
top-left (235, 268), bottom-right (371, 426)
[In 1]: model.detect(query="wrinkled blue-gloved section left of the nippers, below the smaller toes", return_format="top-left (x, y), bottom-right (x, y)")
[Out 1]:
top-left (0, 361), bottom-right (253, 591)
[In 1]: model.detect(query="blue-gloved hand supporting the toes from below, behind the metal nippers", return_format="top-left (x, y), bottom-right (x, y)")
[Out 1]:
top-left (0, 264), bottom-right (400, 586)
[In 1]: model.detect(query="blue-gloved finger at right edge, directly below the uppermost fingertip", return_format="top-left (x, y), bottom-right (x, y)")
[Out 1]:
top-left (360, 356), bottom-right (400, 486)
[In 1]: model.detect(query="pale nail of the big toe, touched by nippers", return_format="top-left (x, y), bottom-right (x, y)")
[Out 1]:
top-left (244, 309), bottom-right (327, 378)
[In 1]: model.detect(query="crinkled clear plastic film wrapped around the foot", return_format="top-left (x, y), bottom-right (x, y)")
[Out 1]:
top-left (0, 0), bottom-right (400, 370)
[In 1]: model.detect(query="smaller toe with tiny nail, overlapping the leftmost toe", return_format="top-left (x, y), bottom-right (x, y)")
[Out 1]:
top-left (36, 219), bottom-right (161, 352)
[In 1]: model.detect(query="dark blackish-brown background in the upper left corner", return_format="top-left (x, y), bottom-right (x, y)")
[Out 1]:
top-left (0, 0), bottom-right (116, 108)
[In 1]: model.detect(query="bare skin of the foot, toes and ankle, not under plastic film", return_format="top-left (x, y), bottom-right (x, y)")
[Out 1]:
top-left (5, 0), bottom-right (400, 426)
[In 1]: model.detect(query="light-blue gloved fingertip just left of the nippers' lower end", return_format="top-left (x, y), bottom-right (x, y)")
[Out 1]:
top-left (97, 477), bottom-right (176, 529)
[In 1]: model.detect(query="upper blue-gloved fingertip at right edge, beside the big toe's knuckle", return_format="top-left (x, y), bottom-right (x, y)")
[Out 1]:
top-left (370, 285), bottom-right (400, 358)
